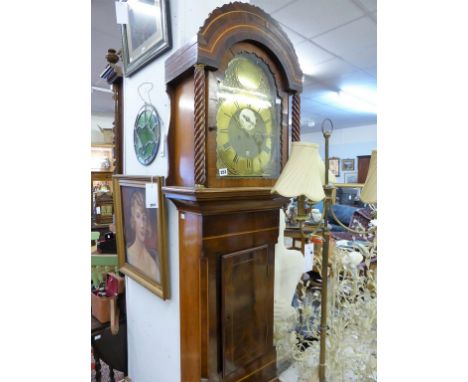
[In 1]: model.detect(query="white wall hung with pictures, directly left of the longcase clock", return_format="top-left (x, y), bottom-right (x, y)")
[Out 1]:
top-left (123, 0), bottom-right (236, 382)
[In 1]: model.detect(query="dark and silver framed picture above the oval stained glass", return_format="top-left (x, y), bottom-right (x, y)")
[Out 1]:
top-left (122, 0), bottom-right (172, 76)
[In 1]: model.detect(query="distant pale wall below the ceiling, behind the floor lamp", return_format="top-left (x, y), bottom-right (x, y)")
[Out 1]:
top-left (301, 125), bottom-right (377, 183)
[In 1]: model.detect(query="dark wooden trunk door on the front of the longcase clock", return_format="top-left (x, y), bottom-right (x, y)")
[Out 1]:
top-left (221, 245), bottom-right (273, 381)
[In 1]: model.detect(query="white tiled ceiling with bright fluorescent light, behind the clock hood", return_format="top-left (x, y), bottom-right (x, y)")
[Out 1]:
top-left (91, 0), bottom-right (377, 133)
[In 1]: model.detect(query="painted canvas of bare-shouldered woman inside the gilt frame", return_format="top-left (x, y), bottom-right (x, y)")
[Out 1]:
top-left (125, 190), bottom-right (161, 283)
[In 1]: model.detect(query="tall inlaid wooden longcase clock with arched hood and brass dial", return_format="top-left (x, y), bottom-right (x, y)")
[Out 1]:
top-left (163, 3), bottom-right (302, 382)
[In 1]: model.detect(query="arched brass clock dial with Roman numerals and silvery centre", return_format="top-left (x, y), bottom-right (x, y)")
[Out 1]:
top-left (216, 53), bottom-right (280, 178)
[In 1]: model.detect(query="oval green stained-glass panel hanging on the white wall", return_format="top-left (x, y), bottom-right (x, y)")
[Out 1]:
top-left (133, 104), bottom-right (161, 166)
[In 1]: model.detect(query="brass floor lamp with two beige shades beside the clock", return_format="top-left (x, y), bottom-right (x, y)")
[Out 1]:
top-left (271, 119), bottom-right (377, 382)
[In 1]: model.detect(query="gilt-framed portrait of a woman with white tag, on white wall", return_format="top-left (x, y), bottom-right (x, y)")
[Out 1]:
top-left (113, 175), bottom-right (168, 300)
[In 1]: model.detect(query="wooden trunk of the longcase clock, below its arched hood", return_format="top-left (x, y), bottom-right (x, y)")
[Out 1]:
top-left (163, 187), bottom-right (286, 382)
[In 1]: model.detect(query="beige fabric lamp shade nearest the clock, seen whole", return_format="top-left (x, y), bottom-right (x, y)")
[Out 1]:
top-left (271, 142), bottom-right (336, 202)
